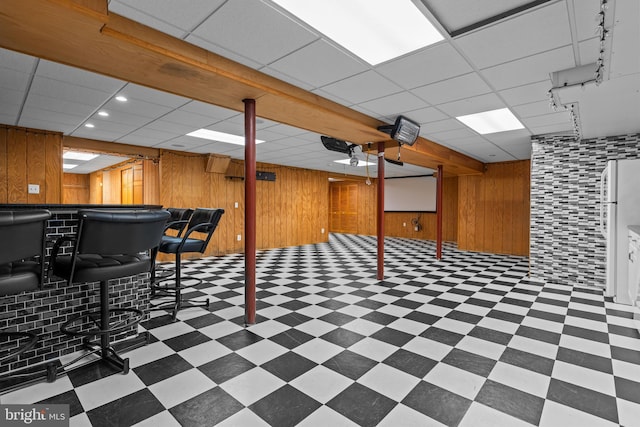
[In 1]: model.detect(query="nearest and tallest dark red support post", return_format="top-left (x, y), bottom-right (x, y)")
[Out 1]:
top-left (242, 99), bottom-right (256, 325)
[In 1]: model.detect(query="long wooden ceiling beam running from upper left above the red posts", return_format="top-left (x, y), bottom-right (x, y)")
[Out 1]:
top-left (0, 0), bottom-right (484, 175)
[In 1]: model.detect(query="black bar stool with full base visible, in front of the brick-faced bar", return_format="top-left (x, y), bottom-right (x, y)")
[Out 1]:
top-left (51, 210), bottom-right (169, 374)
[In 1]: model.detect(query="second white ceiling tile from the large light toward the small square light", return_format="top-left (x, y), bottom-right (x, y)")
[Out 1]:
top-left (411, 73), bottom-right (491, 105)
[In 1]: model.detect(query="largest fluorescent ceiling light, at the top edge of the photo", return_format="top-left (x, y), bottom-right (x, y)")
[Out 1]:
top-left (272, 0), bottom-right (443, 65)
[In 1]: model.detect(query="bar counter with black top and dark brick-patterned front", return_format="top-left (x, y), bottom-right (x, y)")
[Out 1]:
top-left (0, 204), bottom-right (162, 374)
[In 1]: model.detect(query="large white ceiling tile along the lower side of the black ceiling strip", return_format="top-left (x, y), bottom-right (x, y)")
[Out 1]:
top-left (456, 2), bottom-right (571, 69)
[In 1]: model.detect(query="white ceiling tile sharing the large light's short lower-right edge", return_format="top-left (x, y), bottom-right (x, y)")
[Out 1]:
top-left (376, 42), bottom-right (473, 89)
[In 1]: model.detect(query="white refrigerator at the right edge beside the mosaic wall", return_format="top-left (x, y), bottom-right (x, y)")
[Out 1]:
top-left (600, 159), bottom-right (640, 304)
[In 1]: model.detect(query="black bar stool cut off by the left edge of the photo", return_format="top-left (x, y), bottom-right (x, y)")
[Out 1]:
top-left (0, 210), bottom-right (51, 364)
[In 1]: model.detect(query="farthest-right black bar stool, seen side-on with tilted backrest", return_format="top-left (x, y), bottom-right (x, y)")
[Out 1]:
top-left (151, 208), bottom-right (224, 320)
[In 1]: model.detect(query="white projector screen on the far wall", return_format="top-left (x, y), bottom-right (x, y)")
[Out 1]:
top-left (384, 176), bottom-right (436, 212)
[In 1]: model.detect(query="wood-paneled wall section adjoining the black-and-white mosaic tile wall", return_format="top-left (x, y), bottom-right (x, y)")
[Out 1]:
top-left (458, 160), bottom-right (531, 255)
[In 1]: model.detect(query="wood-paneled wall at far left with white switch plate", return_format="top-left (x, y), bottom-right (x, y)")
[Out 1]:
top-left (0, 125), bottom-right (62, 204)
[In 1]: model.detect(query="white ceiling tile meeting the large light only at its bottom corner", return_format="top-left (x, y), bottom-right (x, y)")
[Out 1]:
top-left (322, 71), bottom-right (402, 104)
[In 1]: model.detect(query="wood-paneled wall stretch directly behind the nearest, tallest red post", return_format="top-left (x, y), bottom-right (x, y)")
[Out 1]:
top-left (159, 151), bottom-right (329, 259)
